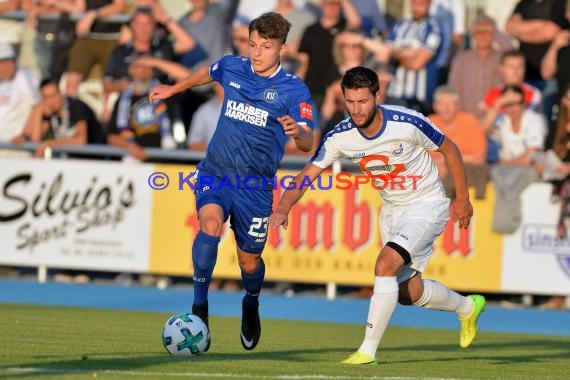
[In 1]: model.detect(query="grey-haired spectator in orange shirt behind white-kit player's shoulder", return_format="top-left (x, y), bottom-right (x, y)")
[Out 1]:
top-left (429, 86), bottom-right (488, 199)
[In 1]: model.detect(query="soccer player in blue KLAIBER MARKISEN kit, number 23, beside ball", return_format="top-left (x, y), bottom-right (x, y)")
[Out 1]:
top-left (149, 12), bottom-right (313, 350)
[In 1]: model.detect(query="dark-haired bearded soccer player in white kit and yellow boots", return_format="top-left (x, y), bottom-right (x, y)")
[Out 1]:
top-left (269, 67), bottom-right (485, 364)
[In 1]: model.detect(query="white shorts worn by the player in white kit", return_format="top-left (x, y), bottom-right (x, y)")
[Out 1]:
top-left (380, 198), bottom-right (450, 283)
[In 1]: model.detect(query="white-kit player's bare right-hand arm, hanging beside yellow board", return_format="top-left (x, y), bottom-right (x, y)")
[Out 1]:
top-left (439, 137), bottom-right (473, 229)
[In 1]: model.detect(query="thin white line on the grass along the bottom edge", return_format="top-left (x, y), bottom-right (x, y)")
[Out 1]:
top-left (0, 367), bottom-right (466, 380)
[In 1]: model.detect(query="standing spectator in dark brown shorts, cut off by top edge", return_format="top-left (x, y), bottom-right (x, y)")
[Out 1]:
top-left (66, 0), bottom-right (126, 97)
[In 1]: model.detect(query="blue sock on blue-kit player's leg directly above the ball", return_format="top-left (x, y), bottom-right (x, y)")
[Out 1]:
top-left (192, 231), bottom-right (220, 306)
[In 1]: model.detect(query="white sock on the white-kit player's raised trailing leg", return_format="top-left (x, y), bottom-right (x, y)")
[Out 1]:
top-left (414, 280), bottom-right (473, 318)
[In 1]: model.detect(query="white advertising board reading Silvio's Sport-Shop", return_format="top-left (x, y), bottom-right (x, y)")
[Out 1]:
top-left (0, 159), bottom-right (152, 272)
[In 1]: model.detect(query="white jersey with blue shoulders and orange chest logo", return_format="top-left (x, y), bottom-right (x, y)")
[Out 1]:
top-left (311, 105), bottom-right (446, 205)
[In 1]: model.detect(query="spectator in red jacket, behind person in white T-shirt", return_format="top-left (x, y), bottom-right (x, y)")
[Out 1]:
top-left (481, 50), bottom-right (542, 132)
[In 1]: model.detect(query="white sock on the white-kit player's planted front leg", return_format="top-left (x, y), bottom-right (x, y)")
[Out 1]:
top-left (358, 276), bottom-right (398, 357)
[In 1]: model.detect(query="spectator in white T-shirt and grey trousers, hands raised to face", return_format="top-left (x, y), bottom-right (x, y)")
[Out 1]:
top-left (491, 86), bottom-right (546, 233)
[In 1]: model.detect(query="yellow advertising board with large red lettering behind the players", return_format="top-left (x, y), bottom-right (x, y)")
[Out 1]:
top-left (150, 165), bottom-right (502, 291)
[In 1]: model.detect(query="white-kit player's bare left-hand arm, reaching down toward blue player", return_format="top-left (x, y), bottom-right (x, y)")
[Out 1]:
top-left (269, 163), bottom-right (325, 229)
